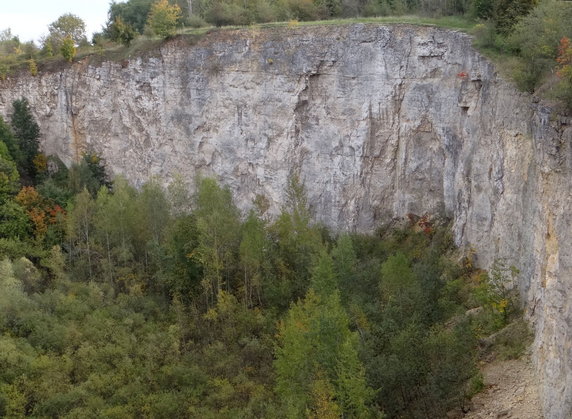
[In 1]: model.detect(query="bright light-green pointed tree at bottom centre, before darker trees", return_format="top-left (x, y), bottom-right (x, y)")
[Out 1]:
top-left (275, 254), bottom-right (372, 418)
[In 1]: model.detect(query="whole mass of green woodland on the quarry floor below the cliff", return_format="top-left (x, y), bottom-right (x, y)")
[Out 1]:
top-left (0, 99), bottom-right (528, 418)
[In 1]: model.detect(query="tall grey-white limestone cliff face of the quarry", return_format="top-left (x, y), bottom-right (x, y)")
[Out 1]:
top-left (0, 25), bottom-right (572, 418)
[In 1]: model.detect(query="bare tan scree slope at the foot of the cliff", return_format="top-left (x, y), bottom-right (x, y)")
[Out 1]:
top-left (464, 354), bottom-right (544, 419)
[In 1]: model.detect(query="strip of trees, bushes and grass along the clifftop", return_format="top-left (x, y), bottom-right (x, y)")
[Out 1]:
top-left (0, 0), bottom-right (572, 109)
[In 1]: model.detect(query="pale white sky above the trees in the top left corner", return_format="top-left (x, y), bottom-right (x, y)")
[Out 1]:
top-left (0, 0), bottom-right (114, 42)
